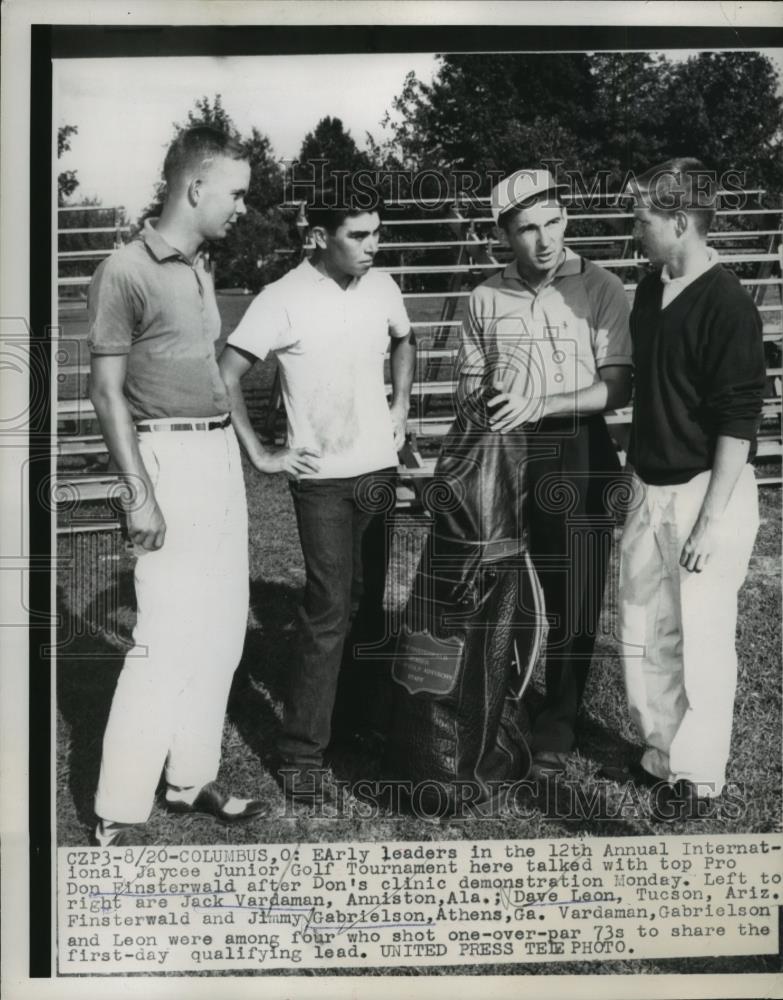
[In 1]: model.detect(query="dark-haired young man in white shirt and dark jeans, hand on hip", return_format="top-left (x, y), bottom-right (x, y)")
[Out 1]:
top-left (220, 185), bottom-right (415, 804)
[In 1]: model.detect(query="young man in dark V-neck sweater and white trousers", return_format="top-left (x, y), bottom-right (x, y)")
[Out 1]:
top-left (620, 158), bottom-right (766, 802)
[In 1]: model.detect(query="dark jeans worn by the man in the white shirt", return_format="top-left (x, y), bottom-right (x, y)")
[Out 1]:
top-left (278, 469), bottom-right (396, 767)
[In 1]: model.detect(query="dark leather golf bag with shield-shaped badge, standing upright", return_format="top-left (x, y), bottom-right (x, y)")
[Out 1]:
top-left (387, 394), bottom-right (546, 815)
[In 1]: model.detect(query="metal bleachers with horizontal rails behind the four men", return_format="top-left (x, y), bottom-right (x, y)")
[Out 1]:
top-left (55, 190), bottom-right (783, 531)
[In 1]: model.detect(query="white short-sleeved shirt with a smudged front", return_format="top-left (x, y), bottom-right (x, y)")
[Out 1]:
top-left (228, 260), bottom-right (410, 479)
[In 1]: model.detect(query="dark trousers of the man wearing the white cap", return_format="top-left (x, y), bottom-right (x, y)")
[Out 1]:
top-left (526, 416), bottom-right (620, 753)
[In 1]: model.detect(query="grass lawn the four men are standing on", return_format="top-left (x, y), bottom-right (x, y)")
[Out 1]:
top-left (52, 296), bottom-right (781, 975)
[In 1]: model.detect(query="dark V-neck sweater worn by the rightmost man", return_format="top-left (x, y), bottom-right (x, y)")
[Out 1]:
top-left (628, 264), bottom-right (766, 486)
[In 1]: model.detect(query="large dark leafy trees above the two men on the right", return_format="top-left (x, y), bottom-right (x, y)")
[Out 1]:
top-left (374, 52), bottom-right (783, 193)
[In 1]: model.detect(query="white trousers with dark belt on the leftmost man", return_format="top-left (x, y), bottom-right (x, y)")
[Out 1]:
top-left (95, 426), bottom-right (248, 823)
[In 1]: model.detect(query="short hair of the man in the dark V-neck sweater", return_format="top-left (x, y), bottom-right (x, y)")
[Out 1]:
top-left (626, 156), bottom-right (718, 236)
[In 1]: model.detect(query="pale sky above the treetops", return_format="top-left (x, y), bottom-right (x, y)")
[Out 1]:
top-left (54, 49), bottom-right (783, 219)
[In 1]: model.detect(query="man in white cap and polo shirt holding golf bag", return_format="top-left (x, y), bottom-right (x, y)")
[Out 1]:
top-left (460, 170), bottom-right (631, 778)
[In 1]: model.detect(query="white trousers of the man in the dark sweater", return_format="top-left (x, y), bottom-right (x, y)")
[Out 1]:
top-left (619, 465), bottom-right (759, 795)
